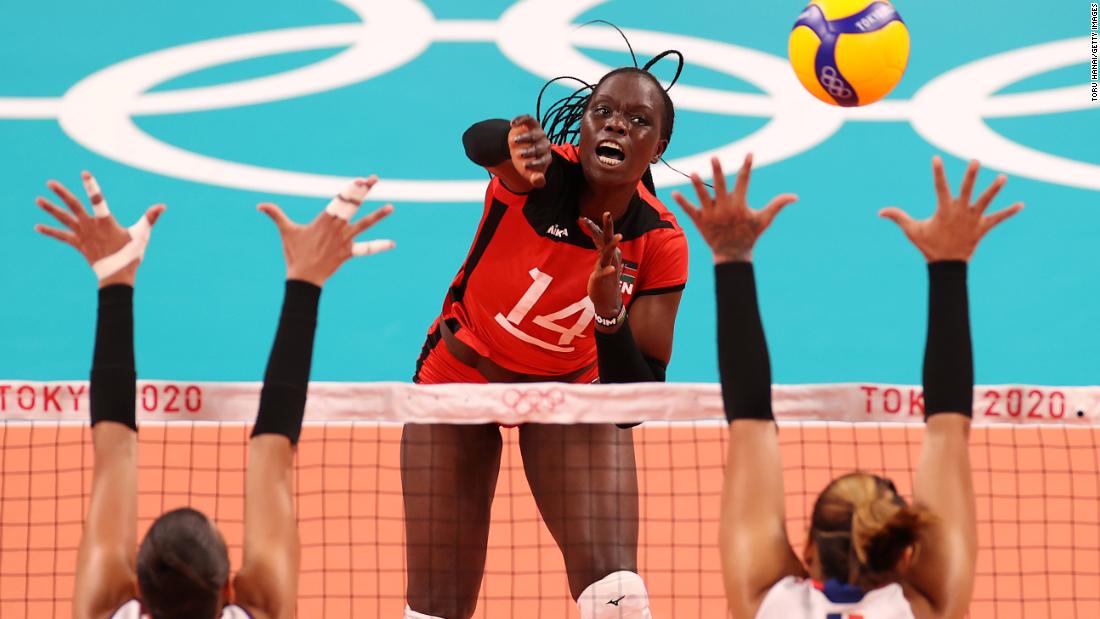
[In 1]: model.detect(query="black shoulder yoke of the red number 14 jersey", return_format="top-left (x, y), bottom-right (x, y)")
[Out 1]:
top-left (524, 153), bottom-right (672, 250)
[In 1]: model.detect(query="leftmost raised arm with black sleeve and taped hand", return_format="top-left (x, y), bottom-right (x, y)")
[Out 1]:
top-left (34, 172), bottom-right (165, 619)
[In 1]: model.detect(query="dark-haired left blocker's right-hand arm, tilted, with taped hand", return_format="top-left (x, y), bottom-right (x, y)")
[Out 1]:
top-left (233, 177), bottom-right (394, 619)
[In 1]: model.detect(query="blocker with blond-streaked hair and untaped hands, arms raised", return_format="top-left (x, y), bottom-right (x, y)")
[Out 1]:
top-left (675, 156), bottom-right (1023, 619)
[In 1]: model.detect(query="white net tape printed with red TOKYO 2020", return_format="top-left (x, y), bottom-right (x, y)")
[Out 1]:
top-left (0, 380), bottom-right (1100, 427)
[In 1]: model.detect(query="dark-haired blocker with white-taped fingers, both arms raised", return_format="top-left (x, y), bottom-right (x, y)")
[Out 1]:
top-left (35, 173), bottom-right (392, 619)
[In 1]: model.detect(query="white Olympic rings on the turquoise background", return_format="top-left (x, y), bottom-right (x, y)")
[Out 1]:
top-left (0, 0), bottom-right (1100, 202)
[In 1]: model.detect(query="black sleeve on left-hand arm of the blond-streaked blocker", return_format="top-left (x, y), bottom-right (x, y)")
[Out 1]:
top-left (714, 262), bottom-right (776, 422)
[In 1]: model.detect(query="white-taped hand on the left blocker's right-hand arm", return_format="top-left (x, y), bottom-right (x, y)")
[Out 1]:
top-left (256, 176), bottom-right (396, 286)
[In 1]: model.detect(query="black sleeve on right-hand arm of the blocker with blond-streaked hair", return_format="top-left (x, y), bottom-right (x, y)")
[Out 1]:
top-left (924, 261), bottom-right (974, 417)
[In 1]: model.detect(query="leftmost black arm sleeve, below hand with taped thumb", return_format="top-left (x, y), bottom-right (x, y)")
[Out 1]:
top-left (88, 284), bottom-right (138, 432)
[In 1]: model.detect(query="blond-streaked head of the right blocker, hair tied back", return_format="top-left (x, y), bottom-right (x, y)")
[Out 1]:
top-left (803, 473), bottom-right (932, 590)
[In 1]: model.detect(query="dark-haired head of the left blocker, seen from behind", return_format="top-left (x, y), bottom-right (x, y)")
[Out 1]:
top-left (138, 507), bottom-right (229, 619)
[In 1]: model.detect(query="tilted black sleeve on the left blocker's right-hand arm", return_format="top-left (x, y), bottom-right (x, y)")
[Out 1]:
top-left (252, 279), bottom-right (321, 444)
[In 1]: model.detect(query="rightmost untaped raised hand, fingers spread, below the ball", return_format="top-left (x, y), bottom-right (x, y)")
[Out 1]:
top-left (879, 156), bottom-right (1024, 262)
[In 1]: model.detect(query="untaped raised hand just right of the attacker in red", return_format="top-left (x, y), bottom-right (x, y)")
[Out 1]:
top-left (672, 153), bottom-right (799, 263)
